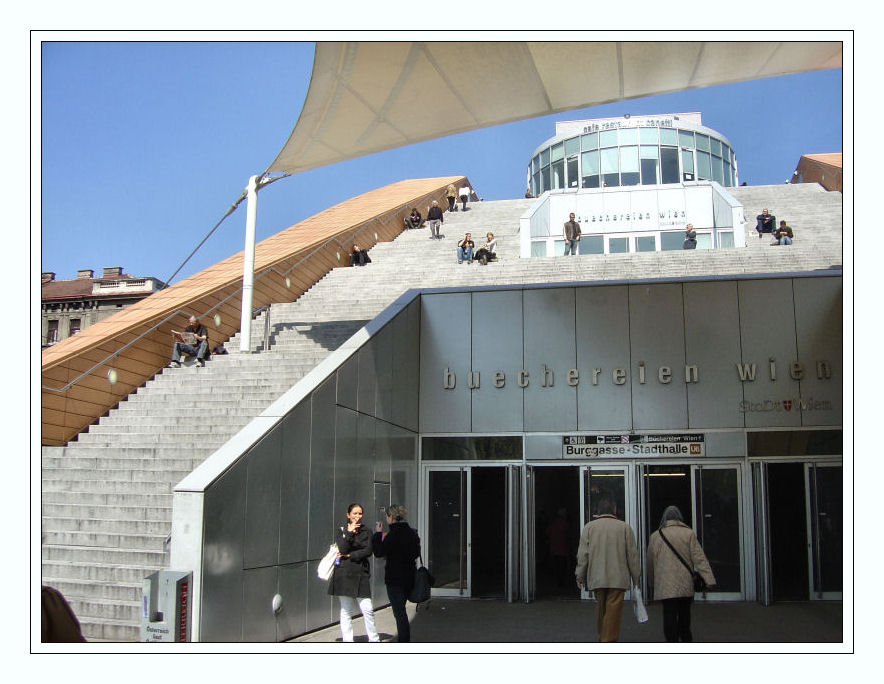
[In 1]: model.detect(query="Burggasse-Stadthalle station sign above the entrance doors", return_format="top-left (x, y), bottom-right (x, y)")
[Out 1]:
top-left (562, 434), bottom-right (706, 458)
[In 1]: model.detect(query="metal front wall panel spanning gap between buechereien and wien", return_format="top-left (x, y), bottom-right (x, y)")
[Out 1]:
top-left (682, 281), bottom-right (743, 428)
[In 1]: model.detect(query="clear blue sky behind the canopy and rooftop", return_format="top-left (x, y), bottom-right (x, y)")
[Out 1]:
top-left (40, 42), bottom-right (842, 282)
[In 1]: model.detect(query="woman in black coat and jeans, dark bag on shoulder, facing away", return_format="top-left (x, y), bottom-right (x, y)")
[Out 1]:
top-left (372, 504), bottom-right (421, 643)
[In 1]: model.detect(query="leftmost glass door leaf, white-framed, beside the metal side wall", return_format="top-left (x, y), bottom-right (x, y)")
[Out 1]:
top-left (426, 466), bottom-right (471, 596)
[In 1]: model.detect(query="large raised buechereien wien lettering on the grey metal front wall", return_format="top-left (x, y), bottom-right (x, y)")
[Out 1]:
top-left (442, 358), bottom-right (832, 390)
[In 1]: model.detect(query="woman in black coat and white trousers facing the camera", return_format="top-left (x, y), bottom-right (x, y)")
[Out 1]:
top-left (328, 503), bottom-right (380, 641)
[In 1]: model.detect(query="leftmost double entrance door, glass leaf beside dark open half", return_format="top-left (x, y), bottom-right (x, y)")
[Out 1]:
top-left (426, 466), bottom-right (521, 600)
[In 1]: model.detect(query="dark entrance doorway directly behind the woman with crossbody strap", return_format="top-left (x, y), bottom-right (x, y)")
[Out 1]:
top-left (639, 464), bottom-right (743, 600)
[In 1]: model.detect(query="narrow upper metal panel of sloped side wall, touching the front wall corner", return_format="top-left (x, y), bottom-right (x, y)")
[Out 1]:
top-left (392, 297), bottom-right (420, 430)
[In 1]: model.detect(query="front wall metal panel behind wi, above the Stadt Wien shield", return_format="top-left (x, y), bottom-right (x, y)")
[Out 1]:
top-left (734, 279), bottom-right (801, 427)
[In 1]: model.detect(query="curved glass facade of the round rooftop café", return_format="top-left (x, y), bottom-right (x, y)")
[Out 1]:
top-left (527, 115), bottom-right (737, 197)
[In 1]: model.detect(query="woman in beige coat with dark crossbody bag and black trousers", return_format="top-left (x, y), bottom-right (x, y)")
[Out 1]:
top-left (648, 506), bottom-right (715, 641)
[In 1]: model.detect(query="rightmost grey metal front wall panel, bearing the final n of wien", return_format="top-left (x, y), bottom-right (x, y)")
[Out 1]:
top-left (793, 278), bottom-right (844, 425)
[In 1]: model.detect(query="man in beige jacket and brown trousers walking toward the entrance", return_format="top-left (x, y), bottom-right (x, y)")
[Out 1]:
top-left (575, 499), bottom-right (640, 642)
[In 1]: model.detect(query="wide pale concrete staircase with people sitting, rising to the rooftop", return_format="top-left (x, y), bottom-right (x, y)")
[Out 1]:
top-left (42, 185), bottom-right (841, 641)
